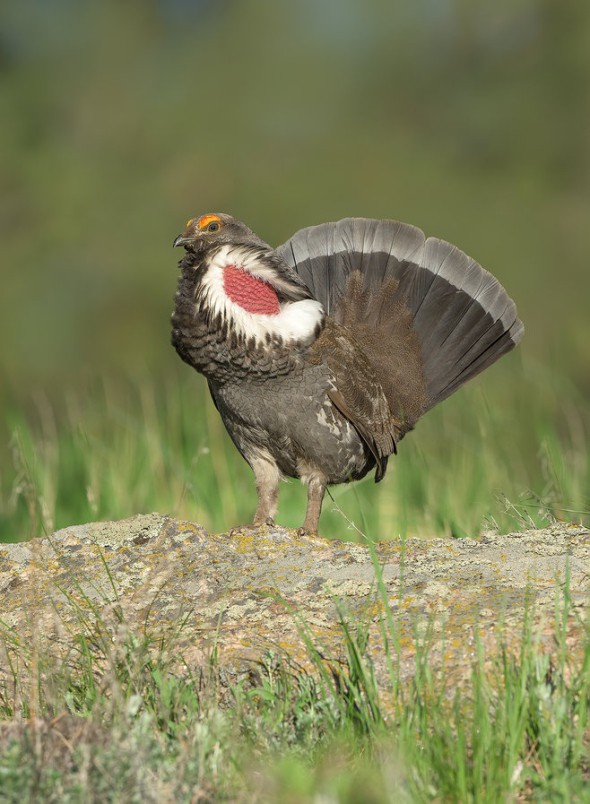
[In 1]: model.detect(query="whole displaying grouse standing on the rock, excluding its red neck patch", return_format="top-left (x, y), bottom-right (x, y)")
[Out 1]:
top-left (172, 215), bottom-right (523, 531)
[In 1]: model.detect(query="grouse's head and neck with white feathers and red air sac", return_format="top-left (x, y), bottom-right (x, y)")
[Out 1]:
top-left (173, 213), bottom-right (324, 344)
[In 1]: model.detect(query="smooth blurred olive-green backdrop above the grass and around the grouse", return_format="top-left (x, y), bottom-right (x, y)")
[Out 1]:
top-left (0, 0), bottom-right (590, 540)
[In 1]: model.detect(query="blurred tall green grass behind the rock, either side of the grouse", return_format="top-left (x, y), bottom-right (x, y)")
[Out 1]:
top-left (0, 363), bottom-right (590, 541)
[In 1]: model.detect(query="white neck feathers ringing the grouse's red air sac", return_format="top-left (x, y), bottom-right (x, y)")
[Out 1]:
top-left (197, 245), bottom-right (324, 344)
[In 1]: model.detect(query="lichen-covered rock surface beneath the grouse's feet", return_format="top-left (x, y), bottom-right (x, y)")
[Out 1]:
top-left (0, 514), bottom-right (590, 690)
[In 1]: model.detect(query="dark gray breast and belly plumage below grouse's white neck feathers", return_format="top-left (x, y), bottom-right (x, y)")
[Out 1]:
top-left (173, 258), bottom-right (382, 483)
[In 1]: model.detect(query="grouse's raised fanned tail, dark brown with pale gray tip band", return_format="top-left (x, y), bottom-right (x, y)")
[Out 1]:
top-left (278, 218), bottom-right (524, 429)
